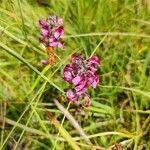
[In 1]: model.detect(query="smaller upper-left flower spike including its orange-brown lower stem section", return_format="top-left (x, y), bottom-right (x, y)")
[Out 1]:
top-left (39, 16), bottom-right (64, 65)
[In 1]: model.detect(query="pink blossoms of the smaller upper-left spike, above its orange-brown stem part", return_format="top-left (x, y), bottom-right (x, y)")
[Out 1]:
top-left (39, 16), bottom-right (64, 48)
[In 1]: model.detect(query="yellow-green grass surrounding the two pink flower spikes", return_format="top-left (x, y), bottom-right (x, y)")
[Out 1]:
top-left (0, 0), bottom-right (150, 150)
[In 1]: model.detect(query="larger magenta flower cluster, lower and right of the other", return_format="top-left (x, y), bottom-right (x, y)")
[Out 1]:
top-left (63, 54), bottom-right (100, 106)
